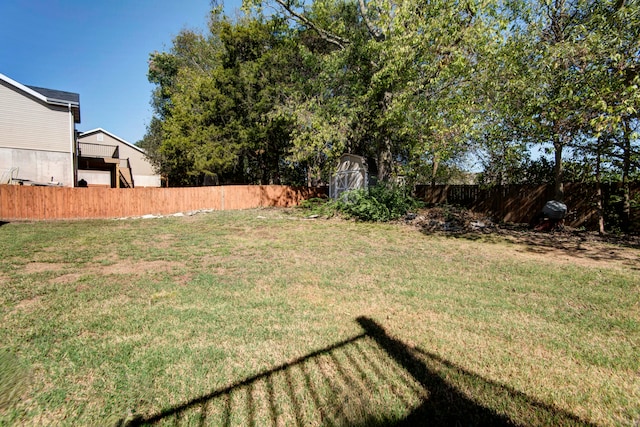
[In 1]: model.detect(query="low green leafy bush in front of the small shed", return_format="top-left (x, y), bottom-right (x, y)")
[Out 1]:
top-left (336, 183), bottom-right (421, 222)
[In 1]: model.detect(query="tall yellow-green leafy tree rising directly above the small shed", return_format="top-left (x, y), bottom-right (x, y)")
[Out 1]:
top-left (245, 0), bottom-right (496, 180)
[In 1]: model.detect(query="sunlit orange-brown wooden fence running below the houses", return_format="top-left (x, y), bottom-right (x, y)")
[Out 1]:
top-left (0, 185), bottom-right (325, 221)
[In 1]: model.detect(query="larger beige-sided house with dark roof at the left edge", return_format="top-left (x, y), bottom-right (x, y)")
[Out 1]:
top-left (0, 74), bottom-right (80, 187)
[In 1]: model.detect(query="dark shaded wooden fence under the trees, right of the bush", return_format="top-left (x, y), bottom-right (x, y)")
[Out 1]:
top-left (416, 182), bottom-right (640, 230)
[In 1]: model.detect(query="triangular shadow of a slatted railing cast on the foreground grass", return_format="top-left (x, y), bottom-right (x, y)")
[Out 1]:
top-left (124, 317), bottom-right (591, 427)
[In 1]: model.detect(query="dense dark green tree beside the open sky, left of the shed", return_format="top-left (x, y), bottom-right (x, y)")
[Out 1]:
top-left (147, 9), bottom-right (308, 185)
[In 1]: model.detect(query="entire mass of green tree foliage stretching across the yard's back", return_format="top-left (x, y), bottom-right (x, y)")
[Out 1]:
top-left (141, 0), bottom-right (640, 202)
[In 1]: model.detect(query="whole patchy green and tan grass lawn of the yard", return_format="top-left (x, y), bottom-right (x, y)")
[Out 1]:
top-left (0, 209), bottom-right (640, 426)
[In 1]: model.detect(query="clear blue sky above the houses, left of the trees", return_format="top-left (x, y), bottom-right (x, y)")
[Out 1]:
top-left (0, 0), bottom-right (241, 143)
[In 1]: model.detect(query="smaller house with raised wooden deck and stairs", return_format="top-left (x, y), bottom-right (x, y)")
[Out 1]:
top-left (78, 128), bottom-right (160, 188)
